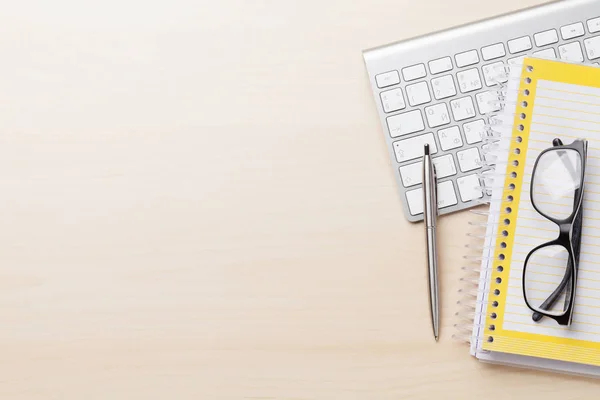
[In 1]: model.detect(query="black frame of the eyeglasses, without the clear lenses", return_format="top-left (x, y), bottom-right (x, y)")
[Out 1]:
top-left (522, 139), bottom-right (588, 325)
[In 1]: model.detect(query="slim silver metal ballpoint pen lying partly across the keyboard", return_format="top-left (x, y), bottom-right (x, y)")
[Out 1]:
top-left (423, 144), bottom-right (440, 342)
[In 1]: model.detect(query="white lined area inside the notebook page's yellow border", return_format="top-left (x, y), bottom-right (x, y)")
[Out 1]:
top-left (503, 80), bottom-right (600, 342)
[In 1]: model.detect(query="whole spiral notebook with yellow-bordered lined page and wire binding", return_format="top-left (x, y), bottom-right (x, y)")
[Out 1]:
top-left (459, 58), bottom-right (600, 376)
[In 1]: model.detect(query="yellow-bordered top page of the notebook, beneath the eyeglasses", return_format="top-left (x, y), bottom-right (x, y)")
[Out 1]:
top-left (482, 58), bottom-right (600, 366)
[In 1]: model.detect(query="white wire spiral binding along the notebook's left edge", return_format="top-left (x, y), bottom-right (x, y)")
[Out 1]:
top-left (453, 64), bottom-right (525, 345)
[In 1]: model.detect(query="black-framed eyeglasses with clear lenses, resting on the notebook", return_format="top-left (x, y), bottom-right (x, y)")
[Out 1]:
top-left (523, 139), bottom-right (588, 325)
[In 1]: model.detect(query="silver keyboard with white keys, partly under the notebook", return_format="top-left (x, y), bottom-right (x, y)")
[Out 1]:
top-left (363, 0), bottom-right (600, 222)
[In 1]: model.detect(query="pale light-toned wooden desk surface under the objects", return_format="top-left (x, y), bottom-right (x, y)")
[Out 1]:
top-left (0, 0), bottom-right (600, 400)
